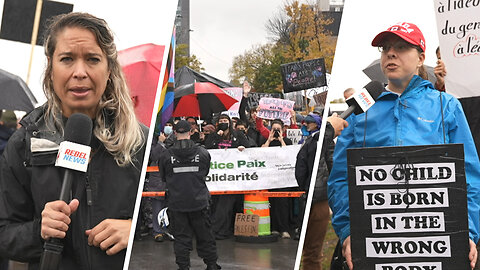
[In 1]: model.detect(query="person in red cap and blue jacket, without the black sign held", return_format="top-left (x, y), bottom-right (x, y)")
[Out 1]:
top-left (328, 23), bottom-right (480, 269)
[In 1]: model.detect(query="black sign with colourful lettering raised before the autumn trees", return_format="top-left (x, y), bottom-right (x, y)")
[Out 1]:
top-left (281, 58), bottom-right (327, 93)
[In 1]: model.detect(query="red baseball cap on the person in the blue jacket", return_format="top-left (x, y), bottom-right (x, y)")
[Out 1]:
top-left (372, 22), bottom-right (426, 52)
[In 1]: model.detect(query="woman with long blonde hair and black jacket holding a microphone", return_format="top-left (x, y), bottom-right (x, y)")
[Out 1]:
top-left (0, 13), bottom-right (148, 269)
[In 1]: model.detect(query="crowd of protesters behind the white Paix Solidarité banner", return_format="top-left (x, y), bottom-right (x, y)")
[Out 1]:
top-left (137, 92), bottom-right (340, 242)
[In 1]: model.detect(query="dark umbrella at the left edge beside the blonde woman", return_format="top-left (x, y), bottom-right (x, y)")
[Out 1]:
top-left (0, 69), bottom-right (37, 112)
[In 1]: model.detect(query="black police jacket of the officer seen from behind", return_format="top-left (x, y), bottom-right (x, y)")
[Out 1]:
top-left (158, 140), bottom-right (210, 212)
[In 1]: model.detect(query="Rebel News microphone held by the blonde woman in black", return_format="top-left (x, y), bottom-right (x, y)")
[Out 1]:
top-left (40, 113), bottom-right (93, 270)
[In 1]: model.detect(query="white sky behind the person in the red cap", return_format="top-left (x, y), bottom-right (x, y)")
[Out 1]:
top-left (329, 0), bottom-right (438, 99)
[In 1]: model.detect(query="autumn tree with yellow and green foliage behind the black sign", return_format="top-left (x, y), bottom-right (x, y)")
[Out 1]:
top-left (229, 1), bottom-right (336, 92)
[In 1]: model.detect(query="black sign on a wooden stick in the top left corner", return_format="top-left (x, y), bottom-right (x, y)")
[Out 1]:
top-left (0, 0), bottom-right (73, 45)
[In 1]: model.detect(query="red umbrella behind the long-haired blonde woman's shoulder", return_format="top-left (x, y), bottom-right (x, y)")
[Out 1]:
top-left (118, 44), bottom-right (165, 126)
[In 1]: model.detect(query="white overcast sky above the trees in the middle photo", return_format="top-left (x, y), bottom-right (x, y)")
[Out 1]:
top-left (190, 0), bottom-right (286, 82)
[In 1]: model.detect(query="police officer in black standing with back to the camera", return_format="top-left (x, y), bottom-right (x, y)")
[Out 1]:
top-left (158, 120), bottom-right (220, 270)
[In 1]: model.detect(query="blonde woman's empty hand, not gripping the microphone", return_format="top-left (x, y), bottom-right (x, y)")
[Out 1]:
top-left (85, 219), bottom-right (132, 255)
